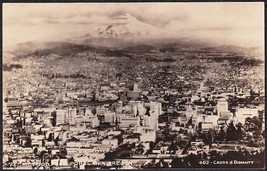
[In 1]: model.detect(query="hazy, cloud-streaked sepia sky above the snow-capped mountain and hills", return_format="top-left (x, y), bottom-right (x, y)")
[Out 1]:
top-left (3, 2), bottom-right (264, 47)
